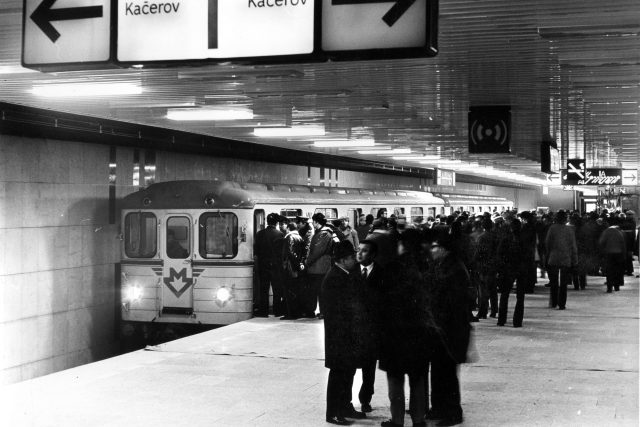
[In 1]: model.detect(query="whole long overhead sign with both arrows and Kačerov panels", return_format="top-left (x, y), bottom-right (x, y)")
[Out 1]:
top-left (22, 0), bottom-right (438, 71)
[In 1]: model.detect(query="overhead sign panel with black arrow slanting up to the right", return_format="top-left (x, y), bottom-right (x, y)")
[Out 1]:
top-left (322, 0), bottom-right (438, 59)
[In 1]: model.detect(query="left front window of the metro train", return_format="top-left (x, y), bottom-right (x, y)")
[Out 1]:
top-left (124, 212), bottom-right (158, 258)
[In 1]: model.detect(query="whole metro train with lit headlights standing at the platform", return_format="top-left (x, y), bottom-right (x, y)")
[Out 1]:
top-left (120, 181), bottom-right (513, 327)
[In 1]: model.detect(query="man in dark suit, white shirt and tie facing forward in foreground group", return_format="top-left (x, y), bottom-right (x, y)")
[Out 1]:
top-left (356, 240), bottom-right (384, 412)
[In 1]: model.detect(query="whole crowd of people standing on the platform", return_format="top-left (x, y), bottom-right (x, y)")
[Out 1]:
top-left (254, 206), bottom-right (639, 427)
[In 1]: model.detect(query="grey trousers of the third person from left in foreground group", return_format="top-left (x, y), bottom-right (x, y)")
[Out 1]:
top-left (387, 372), bottom-right (426, 425)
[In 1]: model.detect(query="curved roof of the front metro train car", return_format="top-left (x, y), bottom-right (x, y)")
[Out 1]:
top-left (121, 180), bottom-right (444, 209)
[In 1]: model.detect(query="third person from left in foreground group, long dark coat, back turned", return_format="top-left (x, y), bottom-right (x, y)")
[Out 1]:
top-left (380, 229), bottom-right (433, 427)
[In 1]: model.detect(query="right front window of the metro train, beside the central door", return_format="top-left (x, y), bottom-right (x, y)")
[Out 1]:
top-left (200, 212), bottom-right (238, 259)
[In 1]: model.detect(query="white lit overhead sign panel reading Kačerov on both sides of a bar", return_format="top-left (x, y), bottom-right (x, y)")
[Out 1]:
top-left (117, 0), bottom-right (314, 62)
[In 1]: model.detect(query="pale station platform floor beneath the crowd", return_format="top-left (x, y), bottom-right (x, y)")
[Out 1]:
top-left (0, 268), bottom-right (639, 427)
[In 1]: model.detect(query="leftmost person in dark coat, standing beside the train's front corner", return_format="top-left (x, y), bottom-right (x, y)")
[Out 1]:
top-left (254, 213), bottom-right (284, 317)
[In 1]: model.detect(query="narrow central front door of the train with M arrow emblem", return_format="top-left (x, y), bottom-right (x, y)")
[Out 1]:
top-left (162, 214), bottom-right (193, 315)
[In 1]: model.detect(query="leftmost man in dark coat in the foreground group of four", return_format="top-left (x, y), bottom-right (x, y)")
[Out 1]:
top-left (322, 241), bottom-right (366, 425)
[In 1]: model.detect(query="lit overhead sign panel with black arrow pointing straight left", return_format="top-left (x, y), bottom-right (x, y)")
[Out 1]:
top-left (22, 0), bottom-right (111, 68)
